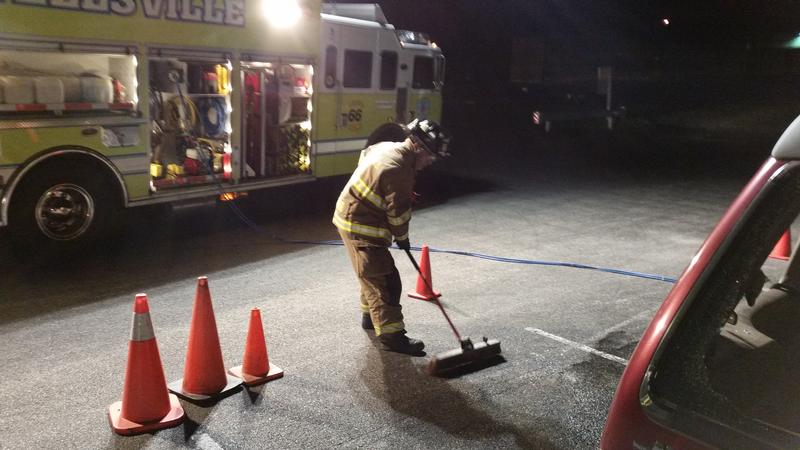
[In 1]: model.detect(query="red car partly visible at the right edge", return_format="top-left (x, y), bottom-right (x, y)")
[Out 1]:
top-left (601, 118), bottom-right (800, 450)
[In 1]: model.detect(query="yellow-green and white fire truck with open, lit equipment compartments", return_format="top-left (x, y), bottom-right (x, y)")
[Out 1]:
top-left (0, 0), bottom-right (444, 247)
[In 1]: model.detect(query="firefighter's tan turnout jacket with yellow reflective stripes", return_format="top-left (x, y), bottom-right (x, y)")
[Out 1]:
top-left (333, 142), bottom-right (415, 246)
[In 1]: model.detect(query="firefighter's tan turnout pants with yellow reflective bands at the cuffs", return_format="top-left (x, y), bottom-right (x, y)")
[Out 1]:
top-left (339, 231), bottom-right (405, 335)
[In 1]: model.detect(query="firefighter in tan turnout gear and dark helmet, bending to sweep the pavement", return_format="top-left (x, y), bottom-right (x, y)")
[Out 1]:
top-left (333, 120), bottom-right (450, 355)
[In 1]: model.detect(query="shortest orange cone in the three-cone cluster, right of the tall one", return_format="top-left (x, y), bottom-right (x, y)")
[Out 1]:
top-left (228, 308), bottom-right (283, 386)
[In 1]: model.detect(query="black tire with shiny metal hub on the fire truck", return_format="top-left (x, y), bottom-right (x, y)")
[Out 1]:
top-left (9, 162), bottom-right (118, 250)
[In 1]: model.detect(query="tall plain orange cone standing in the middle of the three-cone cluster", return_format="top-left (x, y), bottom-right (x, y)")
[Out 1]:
top-left (168, 277), bottom-right (242, 402)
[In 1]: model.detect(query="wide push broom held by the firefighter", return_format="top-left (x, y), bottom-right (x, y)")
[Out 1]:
top-left (406, 249), bottom-right (500, 375)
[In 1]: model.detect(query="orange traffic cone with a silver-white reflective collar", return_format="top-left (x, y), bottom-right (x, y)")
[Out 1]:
top-left (108, 294), bottom-right (184, 435)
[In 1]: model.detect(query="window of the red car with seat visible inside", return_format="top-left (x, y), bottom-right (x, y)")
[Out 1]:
top-left (650, 165), bottom-right (800, 447)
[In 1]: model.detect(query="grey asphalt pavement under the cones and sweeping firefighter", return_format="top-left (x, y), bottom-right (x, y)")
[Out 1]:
top-left (0, 114), bottom-right (777, 449)
